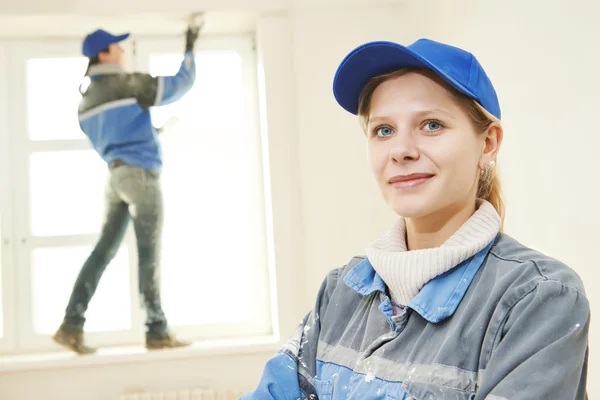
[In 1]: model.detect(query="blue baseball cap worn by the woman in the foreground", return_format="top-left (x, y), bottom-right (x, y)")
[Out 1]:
top-left (333, 39), bottom-right (501, 119)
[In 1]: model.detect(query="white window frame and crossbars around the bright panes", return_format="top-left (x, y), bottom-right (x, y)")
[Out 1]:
top-left (0, 35), bottom-right (277, 354)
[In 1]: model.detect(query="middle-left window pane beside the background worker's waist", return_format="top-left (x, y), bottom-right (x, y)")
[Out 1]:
top-left (30, 150), bottom-right (107, 236)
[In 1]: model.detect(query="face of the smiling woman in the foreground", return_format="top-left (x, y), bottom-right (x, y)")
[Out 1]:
top-left (367, 72), bottom-right (492, 218)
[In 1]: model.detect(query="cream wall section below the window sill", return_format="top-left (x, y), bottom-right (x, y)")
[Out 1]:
top-left (0, 353), bottom-right (267, 400)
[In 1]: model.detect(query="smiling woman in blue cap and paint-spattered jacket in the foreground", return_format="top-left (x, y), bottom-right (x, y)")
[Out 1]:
top-left (243, 39), bottom-right (590, 400)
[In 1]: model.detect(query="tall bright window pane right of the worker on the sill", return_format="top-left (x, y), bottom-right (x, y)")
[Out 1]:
top-left (150, 53), bottom-right (266, 325)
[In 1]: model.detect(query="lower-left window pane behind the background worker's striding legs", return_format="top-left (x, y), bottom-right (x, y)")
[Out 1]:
top-left (31, 246), bottom-right (131, 334)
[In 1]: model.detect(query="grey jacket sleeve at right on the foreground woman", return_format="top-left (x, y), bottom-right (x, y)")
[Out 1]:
top-left (476, 280), bottom-right (590, 400)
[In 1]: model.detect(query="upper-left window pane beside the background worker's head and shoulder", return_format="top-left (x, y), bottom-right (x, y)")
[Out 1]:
top-left (27, 57), bottom-right (88, 140)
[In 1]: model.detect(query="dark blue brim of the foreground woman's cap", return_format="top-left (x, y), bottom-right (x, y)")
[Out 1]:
top-left (333, 42), bottom-right (478, 115)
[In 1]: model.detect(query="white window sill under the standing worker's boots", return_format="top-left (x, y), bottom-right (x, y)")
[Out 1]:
top-left (0, 335), bottom-right (281, 372)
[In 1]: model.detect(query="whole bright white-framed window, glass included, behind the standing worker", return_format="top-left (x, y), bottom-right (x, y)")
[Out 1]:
top-left (0, 34), bottom-right (272, 352)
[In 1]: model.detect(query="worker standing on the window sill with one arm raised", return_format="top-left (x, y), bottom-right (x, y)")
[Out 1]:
top-left (53, 21), bottom-right (201, 354)
